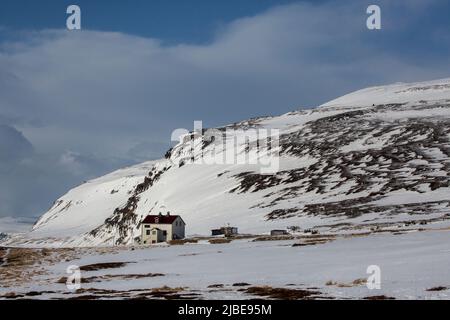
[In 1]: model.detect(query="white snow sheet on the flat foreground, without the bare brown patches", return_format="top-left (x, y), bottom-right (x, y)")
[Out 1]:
top-left (0, 228), bottom-right (450, 299)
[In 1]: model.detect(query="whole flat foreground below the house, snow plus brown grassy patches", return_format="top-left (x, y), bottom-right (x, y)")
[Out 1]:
top-left (0, 228), bottom-right (450, 299)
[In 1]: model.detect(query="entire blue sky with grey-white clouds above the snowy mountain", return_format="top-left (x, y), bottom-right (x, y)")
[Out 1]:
top-left (0, 0), bottom-right (450, 217)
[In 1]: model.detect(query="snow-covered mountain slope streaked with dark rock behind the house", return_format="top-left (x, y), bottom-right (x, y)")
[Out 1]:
top-left (3, 79), bottom-right (450, 246)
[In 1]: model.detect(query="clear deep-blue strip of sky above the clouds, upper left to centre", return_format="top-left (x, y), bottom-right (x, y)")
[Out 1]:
top-left (0, 0), bottom-right (306, 43)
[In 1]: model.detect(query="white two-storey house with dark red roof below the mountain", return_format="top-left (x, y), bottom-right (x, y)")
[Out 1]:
top-left (141, 213), bottom-right (186, 244)
